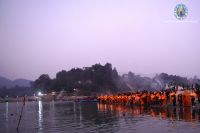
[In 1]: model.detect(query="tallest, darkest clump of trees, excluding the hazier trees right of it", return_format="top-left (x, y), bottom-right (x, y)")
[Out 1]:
top-left (32, 63), bottom-right (119, 95)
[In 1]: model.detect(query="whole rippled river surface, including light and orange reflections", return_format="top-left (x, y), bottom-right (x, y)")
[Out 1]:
top-left (0, 101), bottom-right (200, 133)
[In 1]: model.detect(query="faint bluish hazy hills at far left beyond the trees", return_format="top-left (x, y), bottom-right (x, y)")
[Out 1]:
top-left (0, 77), bottom-right (31, 88)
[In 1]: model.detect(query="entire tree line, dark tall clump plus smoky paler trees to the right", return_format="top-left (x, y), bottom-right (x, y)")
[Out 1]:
top-left (32, 63), bottom-right (200, 95)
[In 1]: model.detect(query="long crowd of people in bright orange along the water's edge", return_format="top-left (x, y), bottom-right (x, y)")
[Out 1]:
top-left (98, 89), bottom-right (200, 106)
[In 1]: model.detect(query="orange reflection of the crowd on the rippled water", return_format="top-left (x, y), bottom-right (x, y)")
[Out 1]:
top-left (98, 103), bottom-right (200, 122)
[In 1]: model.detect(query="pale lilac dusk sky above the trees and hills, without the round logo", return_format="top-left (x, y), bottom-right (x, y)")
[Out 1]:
top-left (0, 0), bottom-right (200, 80)
